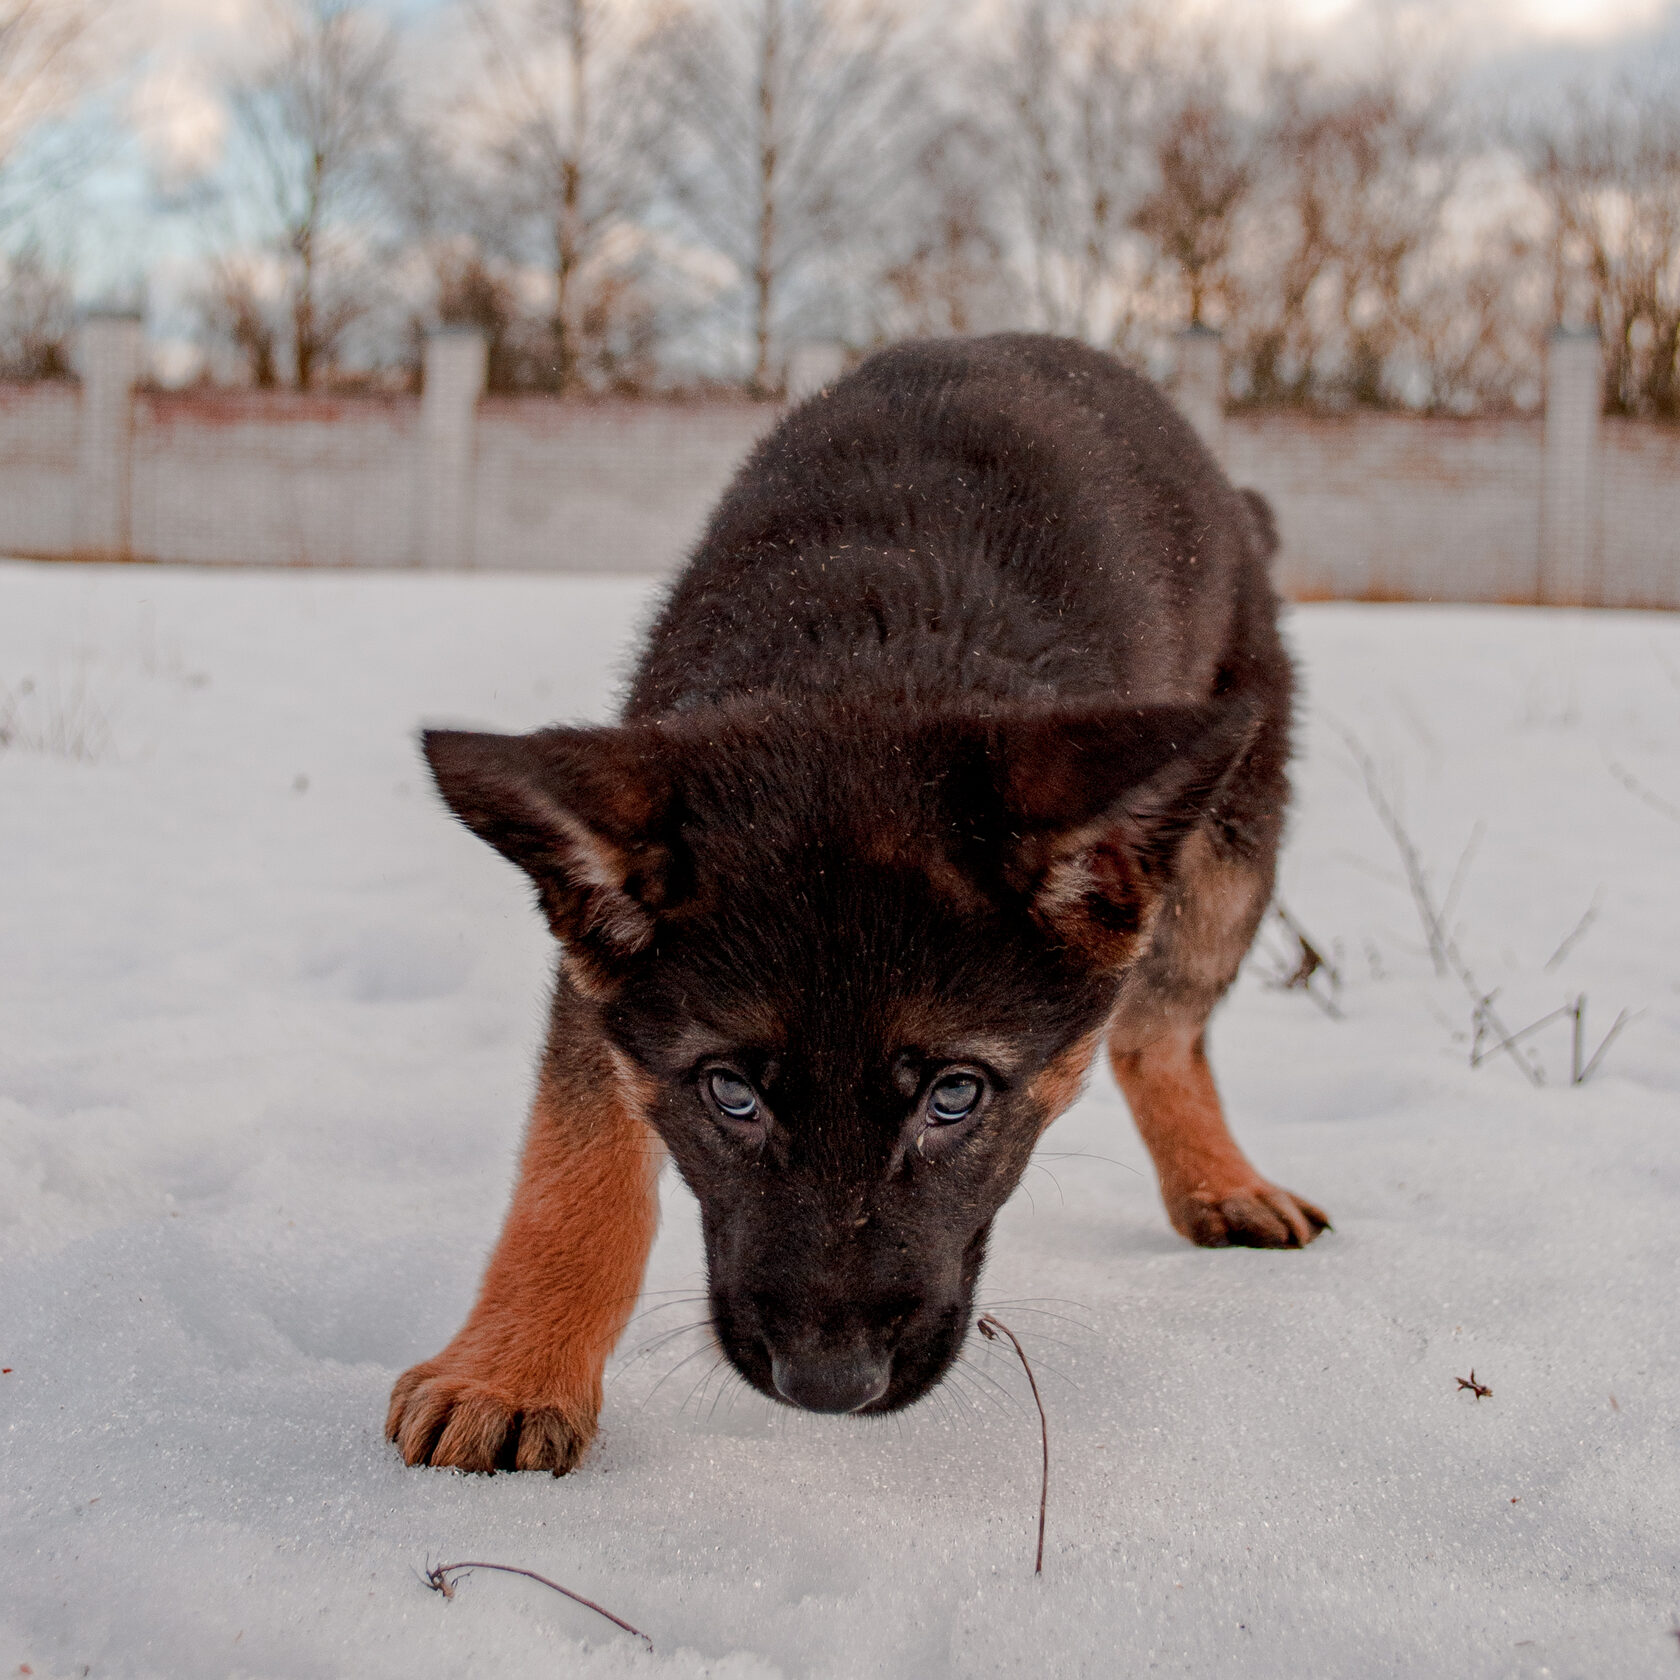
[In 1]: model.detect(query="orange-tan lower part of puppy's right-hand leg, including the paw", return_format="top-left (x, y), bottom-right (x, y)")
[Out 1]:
top-left (1110, 1028), bottom-right (1331, 1248)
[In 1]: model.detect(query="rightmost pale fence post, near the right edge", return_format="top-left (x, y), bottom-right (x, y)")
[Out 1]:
top-left (1536, 328), bottom-right (1604, 606)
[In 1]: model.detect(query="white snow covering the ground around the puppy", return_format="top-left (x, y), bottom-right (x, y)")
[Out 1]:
top-left (0, 566), bottom-right (1680, 1680)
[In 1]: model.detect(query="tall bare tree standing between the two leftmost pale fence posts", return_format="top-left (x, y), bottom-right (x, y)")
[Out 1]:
top-left (212, 0), bottom-right (393, 390)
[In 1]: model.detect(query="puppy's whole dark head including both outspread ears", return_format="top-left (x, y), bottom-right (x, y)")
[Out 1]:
top-left (425, 706), bottom-right (1252, 1411)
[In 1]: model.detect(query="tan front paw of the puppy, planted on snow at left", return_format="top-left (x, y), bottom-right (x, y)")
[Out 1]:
top-left (385, 1352), bottom-right (600, 1475)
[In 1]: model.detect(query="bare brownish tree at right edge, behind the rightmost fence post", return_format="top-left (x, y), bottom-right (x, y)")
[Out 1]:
top-left (1527, 84), bottom-right (1680, 420)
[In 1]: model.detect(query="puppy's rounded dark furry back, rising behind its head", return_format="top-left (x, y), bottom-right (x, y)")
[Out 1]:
top-left (628, 334), bottom-right (1282, 717)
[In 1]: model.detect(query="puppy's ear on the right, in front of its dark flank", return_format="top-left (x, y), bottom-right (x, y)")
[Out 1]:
top-left (986, 701), bottom-right (1258, 964)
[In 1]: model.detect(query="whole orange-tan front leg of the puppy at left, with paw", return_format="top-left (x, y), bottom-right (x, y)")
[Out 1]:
top-left (385, 969), bottom-right (664, 1475)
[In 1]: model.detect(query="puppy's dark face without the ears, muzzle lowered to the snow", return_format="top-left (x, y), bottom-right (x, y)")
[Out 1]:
top-left (608, 840), bottom-right (1110, 1411)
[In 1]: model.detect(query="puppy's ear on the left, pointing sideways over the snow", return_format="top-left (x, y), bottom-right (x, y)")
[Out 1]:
top-left (422, 729), bottom-right (674, 961)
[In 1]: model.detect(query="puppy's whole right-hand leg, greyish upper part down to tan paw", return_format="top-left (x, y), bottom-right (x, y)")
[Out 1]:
top-left (1109, 835), bottom-right (1331, 1248)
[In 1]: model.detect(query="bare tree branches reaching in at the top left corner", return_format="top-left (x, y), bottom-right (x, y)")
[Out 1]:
top-left (0, 0), bottom-right (104, 228)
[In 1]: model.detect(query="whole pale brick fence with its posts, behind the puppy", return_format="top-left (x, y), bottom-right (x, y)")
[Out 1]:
top-left (0, 316), bottom-right (1680, 608)
